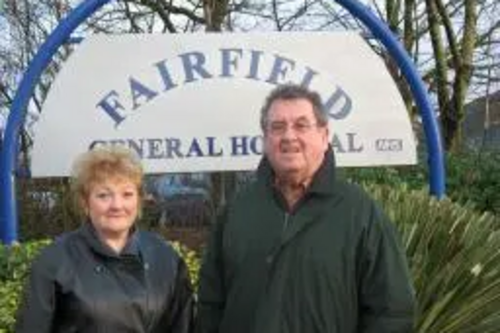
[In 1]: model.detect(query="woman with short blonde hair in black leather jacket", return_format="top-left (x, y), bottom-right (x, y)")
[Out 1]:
top-left (16, 147), bottom-right (193, 333)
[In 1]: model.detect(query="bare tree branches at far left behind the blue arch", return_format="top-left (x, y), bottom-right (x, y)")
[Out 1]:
top-left (0, 0), bottom-right (75, 167)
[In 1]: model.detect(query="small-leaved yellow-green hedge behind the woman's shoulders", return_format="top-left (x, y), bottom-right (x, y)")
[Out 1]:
top-left (0, 240), bottom-right (200, 333)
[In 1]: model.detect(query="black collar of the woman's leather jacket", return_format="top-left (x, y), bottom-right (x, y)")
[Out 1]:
top-left (80, 220), bottom-right (140, 259)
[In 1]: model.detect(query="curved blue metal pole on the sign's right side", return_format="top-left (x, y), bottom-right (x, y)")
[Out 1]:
top-left (335, 0), bottom-right (446, 198)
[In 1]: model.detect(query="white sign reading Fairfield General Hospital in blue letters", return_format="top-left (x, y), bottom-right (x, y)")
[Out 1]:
top-left (32, 32), bottom-right (416, 177)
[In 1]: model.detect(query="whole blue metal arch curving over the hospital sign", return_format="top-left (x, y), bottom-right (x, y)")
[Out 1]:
top-left (0, 0), bottom-right (445, 245)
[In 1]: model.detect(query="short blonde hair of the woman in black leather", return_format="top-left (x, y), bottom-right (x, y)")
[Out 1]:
top-left (71, 146), bottom-right (144, 211)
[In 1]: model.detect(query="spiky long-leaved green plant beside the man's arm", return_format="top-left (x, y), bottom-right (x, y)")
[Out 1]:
top-left (368, 186), bottom-right (500, 333)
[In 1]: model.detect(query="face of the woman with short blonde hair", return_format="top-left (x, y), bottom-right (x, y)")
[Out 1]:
top-left (85, 178), bottom-right (140, 238)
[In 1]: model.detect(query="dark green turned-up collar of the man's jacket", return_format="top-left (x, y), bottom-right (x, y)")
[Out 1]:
top-left (257, 145), bottom-right (336, 195)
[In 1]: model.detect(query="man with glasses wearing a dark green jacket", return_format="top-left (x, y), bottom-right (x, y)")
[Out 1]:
top-left (198, 85), bottom-right (414, 333)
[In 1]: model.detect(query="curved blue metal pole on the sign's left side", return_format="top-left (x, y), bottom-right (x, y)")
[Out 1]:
top-left (0, 0), bottom-right (110, 245)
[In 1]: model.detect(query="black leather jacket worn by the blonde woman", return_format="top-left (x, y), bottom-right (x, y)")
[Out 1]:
top-left (16, 222), bottom-right (193, 333)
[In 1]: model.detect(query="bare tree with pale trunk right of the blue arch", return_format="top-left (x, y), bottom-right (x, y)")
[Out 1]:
top-left (376, 0), bottom-right (500, 150)
